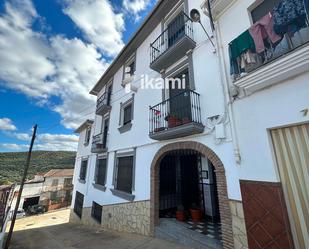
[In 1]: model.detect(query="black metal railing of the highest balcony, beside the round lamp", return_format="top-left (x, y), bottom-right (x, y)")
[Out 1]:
top-left (150, 12), bottom-right (193, 63)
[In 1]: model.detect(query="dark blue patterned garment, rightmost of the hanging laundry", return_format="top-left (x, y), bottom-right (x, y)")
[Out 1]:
top-left (272, 0), bottom-right (306, 35)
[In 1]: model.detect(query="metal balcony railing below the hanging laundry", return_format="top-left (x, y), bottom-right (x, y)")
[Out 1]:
top-left (231, 23), bottom-right (309, 81)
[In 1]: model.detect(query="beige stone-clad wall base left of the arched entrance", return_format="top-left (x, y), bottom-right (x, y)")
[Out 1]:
top-left (70, 201), bottom-right (150, 236)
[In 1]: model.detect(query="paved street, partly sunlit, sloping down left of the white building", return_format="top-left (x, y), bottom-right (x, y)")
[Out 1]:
top-left (10, 210), bottom-right (185, 249)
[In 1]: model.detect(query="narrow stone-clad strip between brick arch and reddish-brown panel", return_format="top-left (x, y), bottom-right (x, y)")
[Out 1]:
top-left (230, 200), bottom-right (248, 249)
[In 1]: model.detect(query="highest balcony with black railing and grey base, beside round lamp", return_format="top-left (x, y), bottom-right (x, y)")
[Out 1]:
top-left (150, 12), bottom-right (196, 72)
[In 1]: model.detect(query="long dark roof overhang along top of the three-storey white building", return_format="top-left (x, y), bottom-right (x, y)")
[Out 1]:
top-left (90, 0), bottom-right (180, 95)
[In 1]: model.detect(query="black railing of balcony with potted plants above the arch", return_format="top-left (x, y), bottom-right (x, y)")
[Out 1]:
top-left (149, 90), bottom-right (202, 134)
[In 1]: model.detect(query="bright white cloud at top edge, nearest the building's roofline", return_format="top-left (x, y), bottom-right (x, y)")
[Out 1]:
top-left (63, 0), bottom-right (125, 56)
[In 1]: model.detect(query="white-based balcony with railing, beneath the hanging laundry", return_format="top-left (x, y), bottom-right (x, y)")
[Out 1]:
top-left (231, 27), bottom-right (309, 95)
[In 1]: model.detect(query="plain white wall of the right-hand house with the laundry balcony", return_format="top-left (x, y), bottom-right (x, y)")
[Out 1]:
top-left (217, 0), bottom-right (309, 182)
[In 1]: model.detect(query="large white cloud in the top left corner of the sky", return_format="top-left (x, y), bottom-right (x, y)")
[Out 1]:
top-left (0, 0), bottom-right (56, 98)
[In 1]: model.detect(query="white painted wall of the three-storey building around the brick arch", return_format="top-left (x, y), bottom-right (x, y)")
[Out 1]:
top-left (72, 0), bottom-right (241, 210)
